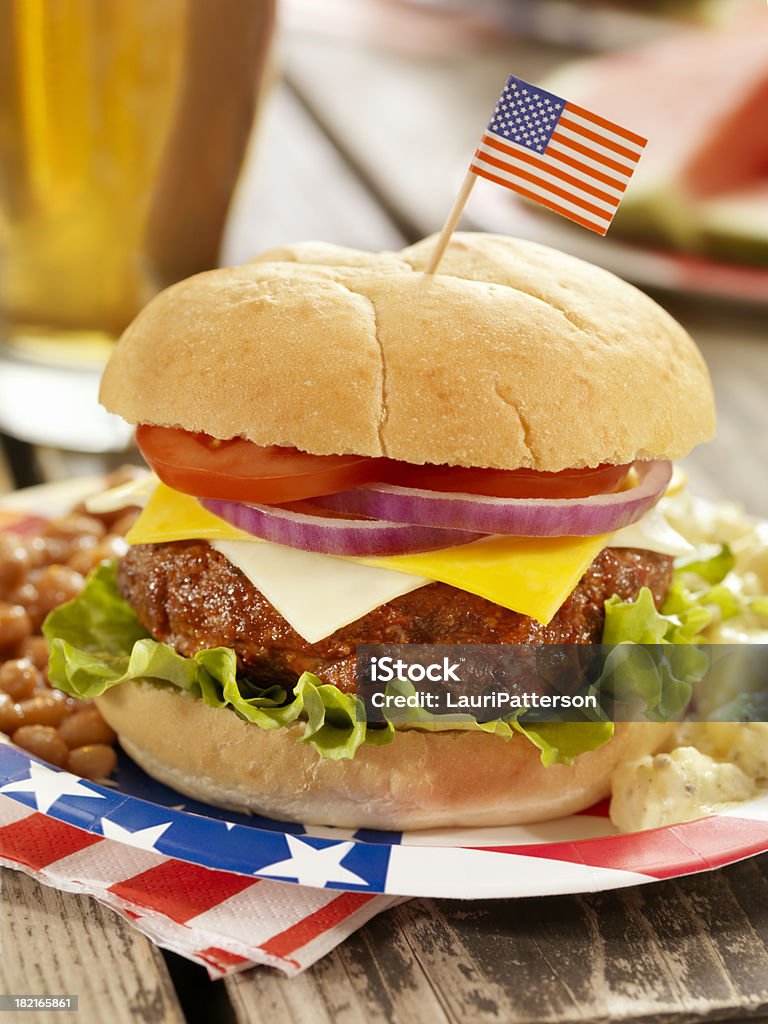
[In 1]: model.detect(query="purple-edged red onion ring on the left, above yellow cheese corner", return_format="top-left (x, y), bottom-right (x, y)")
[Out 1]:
top-left (200, 498), bottom-right (478, 556)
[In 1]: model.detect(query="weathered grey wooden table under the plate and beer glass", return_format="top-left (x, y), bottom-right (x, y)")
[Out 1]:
top-left (0, 18), bottom-right (768, 1024)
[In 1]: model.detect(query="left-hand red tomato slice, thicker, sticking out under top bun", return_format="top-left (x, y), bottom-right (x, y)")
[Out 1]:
top-left (136, 424), bottom-right (391, 505)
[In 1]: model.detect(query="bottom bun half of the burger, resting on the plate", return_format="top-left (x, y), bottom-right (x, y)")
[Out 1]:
top-left (96, 680), bottom-right (671, 831)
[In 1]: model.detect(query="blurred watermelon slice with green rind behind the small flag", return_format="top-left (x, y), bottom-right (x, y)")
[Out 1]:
top-left (547, 11), bottom-right (768, 261)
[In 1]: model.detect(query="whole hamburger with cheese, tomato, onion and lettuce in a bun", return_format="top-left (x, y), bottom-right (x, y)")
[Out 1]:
top-left (45, 233), bottom-right (714, 829)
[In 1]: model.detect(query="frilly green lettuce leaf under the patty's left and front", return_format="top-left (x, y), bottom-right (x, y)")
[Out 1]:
top-left (43, 563), bottom-right (613, 765)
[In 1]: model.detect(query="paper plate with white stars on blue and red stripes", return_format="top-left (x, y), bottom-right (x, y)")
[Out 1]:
top-left (0, 480), bottom-right (768, 899)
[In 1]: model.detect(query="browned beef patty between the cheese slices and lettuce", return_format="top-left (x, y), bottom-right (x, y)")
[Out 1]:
top-left (118, 541), bottom-right (673, 692)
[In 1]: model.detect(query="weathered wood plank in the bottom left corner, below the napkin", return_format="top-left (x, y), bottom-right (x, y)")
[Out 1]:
top-left (0, 868), bottom-right (184, 1024)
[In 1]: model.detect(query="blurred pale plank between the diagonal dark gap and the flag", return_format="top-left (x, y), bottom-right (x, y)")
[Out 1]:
top-left (286, 34), bottom-right (557, 240)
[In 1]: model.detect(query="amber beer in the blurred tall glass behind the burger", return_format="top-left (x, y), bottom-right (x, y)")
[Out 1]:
top-left (0, 0), bottom-right (274, 355)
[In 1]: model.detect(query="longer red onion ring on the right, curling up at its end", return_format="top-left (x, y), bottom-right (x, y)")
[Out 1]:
top-left (312, 461), bottom-right (672, 543)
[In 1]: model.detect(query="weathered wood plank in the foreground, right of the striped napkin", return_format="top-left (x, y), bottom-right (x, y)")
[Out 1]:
top-left (227, 857), bottom-right (768, 1024)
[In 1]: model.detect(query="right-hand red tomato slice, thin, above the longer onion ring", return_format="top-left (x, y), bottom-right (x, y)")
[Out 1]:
top-left (384, 460), bottom-right (630, 498)
